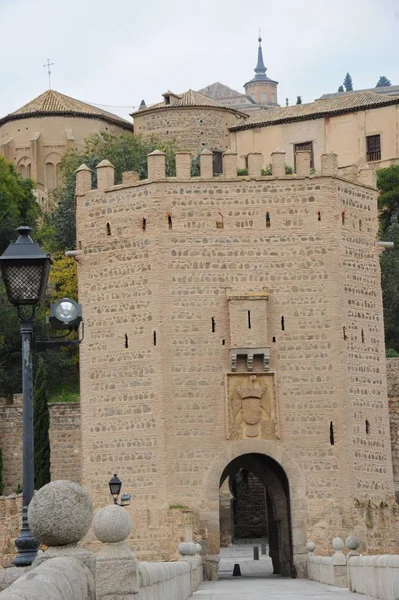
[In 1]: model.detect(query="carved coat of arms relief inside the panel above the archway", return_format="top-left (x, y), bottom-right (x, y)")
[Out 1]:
top-left (229, 375), bottom-right (275, 439)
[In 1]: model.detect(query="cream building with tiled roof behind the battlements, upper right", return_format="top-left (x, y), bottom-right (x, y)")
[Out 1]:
top-left (230, 91), bottom-right (399, 178)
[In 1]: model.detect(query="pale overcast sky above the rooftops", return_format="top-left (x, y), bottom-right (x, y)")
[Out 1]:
top-left (0, 0), bottom-right (399, 122)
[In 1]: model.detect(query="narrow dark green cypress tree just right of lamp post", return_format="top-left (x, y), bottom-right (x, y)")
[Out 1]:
top-left (33, 358), bottom-right (50, 490)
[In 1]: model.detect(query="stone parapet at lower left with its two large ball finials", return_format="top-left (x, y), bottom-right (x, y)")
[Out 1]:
top-left (0, 481), bottom-right (203, 600)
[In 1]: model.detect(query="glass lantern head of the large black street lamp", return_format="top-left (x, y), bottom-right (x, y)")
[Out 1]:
top-left (0, 226), bottom-right (51, 307)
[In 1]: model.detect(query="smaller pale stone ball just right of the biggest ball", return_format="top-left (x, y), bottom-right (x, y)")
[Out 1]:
top-left (94, 504), bottom-right (132, 544)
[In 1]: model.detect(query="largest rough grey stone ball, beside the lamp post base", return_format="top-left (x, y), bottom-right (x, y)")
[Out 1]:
top-left (28, 480), bottom-right (93, 546)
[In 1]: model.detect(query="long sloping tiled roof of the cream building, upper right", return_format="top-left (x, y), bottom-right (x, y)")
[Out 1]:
top-left (230, 92), bottom-right (399, 131)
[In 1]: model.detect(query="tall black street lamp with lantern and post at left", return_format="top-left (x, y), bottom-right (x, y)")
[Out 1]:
top-left (0, 226), bottom-right (51, 567)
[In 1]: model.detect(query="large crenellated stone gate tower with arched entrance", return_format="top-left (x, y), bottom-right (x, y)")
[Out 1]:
top-left (76, 152), bottom-right (397, 575)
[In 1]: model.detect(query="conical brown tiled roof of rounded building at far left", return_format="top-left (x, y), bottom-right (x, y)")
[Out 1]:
top-left (0, 90), bottom-right (133, 130)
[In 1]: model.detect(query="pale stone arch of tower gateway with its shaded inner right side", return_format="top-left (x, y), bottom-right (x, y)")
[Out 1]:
top-left (200, 440), bottom-right (307, 578)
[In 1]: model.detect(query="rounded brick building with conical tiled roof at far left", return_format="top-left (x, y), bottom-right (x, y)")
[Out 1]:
top-left (0, 90), bottom-right (132, 206)
